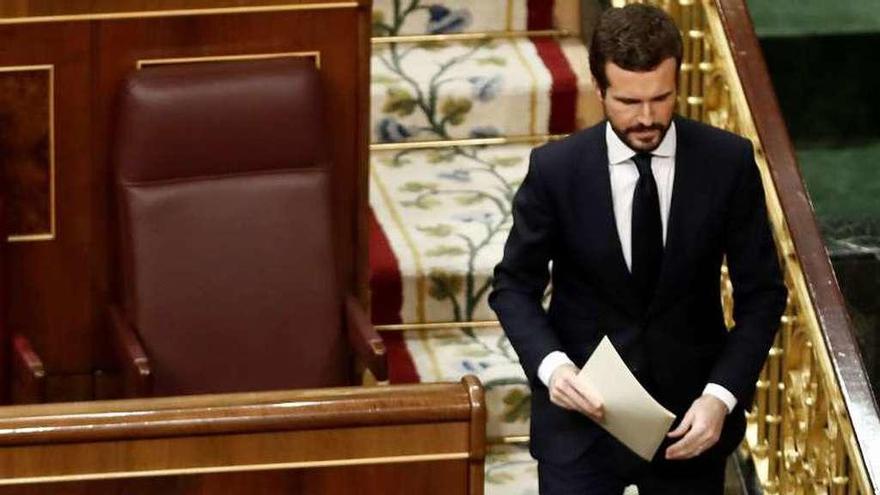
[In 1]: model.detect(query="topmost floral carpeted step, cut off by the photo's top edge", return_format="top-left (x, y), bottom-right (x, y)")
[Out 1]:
top-left (373, 0), bottom-right (580, 36)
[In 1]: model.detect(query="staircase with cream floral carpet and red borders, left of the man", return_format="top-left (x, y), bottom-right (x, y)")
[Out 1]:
top-left (369, 0), bottom-right (602, 494)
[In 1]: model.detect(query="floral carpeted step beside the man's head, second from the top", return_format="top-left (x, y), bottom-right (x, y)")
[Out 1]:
top-left (370, 38), bottom-right (602, 143)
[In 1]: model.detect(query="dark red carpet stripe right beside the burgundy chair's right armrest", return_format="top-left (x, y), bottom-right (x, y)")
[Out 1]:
top-left (369, 208), bottom-right (420, 383)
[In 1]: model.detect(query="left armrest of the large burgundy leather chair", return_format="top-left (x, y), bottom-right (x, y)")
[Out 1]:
top-left (110, 306), bottom-right (153, 397)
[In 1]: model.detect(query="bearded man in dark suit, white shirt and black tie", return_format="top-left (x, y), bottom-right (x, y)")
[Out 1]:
top-left (489, 5), bottom-right (786, 495)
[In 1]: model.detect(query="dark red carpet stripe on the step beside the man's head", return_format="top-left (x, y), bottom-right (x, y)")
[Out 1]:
top-left (530, 37), bottom-right (578, 134)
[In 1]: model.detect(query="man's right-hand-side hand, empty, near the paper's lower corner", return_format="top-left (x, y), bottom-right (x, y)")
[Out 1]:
top-left (666, 394), bottom-right (727, 459)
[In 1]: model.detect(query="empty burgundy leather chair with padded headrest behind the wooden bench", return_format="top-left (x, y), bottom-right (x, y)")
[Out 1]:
top-left (111, 59), bottom-right (387, 395)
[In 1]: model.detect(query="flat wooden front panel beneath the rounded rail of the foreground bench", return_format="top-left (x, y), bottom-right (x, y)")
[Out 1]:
top-left (0, 423), bottom-right (468, 484)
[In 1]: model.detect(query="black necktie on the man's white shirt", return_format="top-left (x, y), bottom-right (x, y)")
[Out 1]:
top-left (632, 153), bottom-right (663, 309)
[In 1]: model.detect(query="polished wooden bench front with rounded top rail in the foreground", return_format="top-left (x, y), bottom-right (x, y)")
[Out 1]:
top-left (0, 376), bottom-right (485, 493)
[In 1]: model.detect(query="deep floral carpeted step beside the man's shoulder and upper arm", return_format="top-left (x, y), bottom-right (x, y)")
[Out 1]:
top-left (370, 144), bottom-right (532, 324)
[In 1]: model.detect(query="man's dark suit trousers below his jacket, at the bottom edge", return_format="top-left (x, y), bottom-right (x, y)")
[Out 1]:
top-left (538, 433), bottom-right (726, 495)
